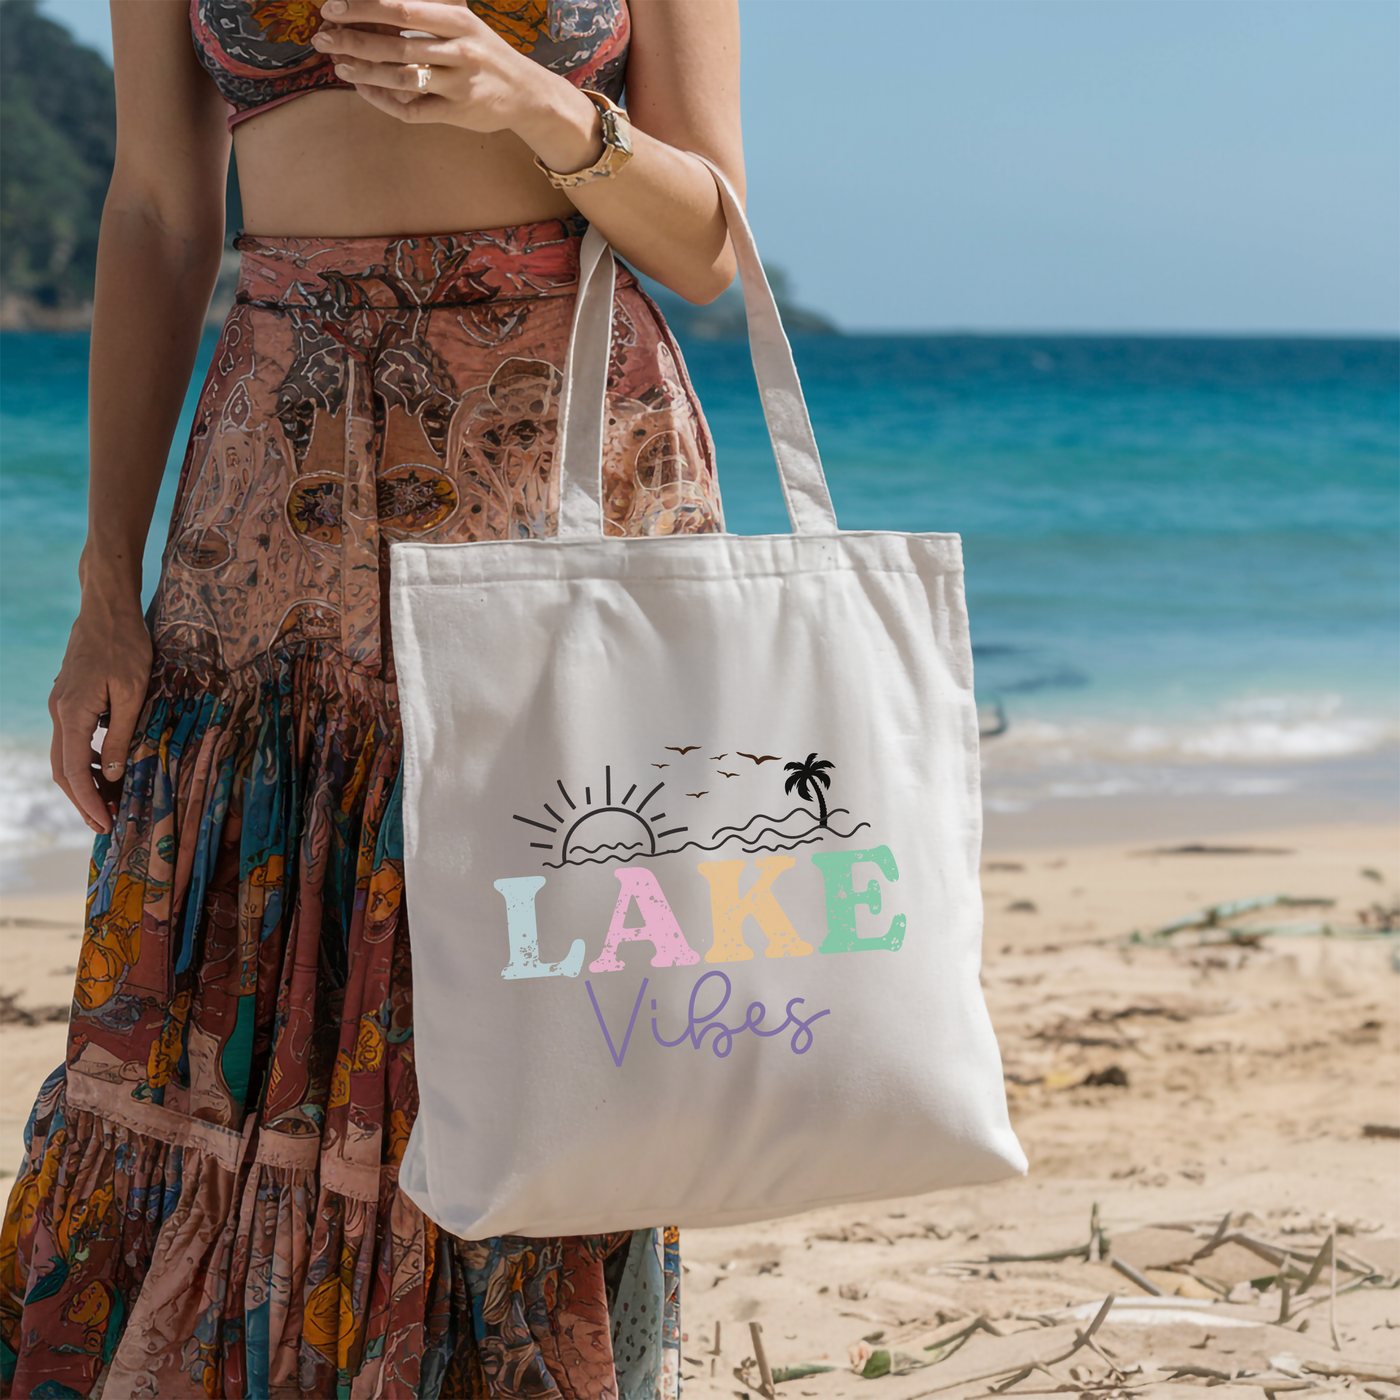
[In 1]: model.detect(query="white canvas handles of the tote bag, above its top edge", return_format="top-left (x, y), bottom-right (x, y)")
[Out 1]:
top-left (559, 151), bottom-right (839, 539)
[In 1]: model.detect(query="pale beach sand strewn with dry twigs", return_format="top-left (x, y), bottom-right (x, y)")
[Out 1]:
top-left (0, 825), bottom-right (1400, 1400)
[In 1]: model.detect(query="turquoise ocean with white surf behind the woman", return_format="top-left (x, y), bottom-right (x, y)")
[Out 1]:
top-left (0, 332), bottom-right (1400, 879)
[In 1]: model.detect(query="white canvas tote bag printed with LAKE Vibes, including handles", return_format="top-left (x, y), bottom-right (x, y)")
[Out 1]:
top-left (391, 162), bottom-right (1025, 1239)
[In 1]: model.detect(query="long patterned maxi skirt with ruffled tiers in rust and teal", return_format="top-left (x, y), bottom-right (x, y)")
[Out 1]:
top-left (0, 217), bottom-right (724, 1400)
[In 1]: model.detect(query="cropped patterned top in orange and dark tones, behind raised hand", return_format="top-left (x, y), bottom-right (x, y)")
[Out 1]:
top-left (189, 0), bottom-right (631, 127)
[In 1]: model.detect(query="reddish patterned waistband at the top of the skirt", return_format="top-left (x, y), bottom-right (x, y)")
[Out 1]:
top-left (234, 214), bottom-right (602, 315)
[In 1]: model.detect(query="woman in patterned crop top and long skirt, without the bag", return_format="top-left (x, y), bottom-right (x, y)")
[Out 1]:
top-left (0, 0), bottom-right (742, 1400)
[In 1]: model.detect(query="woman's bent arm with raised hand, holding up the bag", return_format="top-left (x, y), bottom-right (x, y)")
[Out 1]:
top-left (312, 0), bottom-right (743, 302)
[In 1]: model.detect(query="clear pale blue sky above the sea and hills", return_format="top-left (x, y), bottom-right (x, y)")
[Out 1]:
top-left (43, 0), bottom-right (1400, 335)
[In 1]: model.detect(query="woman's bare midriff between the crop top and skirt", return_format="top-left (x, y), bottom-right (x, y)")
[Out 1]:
top-left (234, 90), bottom-right (574, 238)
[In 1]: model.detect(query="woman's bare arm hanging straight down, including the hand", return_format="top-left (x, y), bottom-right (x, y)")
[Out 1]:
top-left (49, 0), bottom-right (228, 832)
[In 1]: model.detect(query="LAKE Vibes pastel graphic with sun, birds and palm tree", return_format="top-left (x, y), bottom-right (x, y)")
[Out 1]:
top-left (494, 743), bottom-right (906, 1068)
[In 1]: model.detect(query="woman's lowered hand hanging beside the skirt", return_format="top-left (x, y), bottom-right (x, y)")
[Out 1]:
top-left (49, 602), bottom-right (151, 832)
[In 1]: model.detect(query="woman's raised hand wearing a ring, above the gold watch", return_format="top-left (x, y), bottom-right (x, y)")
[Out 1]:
top-left (311, 0), bottom-right (602, 169)
